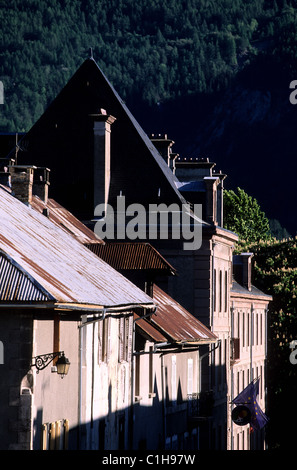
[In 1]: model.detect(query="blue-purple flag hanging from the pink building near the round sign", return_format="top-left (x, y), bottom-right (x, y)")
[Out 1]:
top-left (232, 378), bottom-right (268, 430)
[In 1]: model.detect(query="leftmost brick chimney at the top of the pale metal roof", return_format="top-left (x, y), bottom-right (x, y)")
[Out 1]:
top-left (9, 165), bottom-right (36, 205)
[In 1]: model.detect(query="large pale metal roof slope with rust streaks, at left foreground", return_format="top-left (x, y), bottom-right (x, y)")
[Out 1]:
top-left (0, 188), bottom-right (153, 308)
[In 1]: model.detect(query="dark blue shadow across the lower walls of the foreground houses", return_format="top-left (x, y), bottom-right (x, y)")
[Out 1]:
top-left (33, 374), bottom-right (213, 451)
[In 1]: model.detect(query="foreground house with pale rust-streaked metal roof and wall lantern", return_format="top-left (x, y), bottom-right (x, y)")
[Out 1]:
top-left (0, 166), bottom-right (155, 450)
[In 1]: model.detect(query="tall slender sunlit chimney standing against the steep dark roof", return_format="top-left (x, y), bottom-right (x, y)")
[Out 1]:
top-left (90, 109), bottom-right (116, 209)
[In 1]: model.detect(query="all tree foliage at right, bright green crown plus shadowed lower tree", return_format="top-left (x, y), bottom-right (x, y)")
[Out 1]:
top-left (225, 188), bottom-right (297, 449)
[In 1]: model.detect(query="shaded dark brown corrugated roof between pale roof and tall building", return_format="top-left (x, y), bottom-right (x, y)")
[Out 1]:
top-left (86, 242), bottom-right (176, 274)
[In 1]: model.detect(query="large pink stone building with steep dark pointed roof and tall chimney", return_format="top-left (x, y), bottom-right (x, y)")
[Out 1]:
top-left (2, 58), bottom-right (270, 449)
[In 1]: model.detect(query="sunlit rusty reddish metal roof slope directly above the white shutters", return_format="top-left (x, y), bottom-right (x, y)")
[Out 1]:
top-left (151, 285), bottom-right (217, 344)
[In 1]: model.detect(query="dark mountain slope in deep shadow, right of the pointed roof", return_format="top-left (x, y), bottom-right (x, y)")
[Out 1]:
top-left (136, 57), bottom-right (297, 235)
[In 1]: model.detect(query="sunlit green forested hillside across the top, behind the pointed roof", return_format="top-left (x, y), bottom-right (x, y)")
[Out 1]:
top-left (0, 0), bottom-right (296, 132)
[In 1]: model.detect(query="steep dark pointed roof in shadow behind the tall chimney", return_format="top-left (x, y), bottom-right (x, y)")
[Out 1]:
top-left (12, 59), bottom-right (185, 220)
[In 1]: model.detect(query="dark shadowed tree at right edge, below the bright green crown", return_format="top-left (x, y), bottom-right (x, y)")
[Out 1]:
top-left (245, 238), bottom-right (297, 450)
